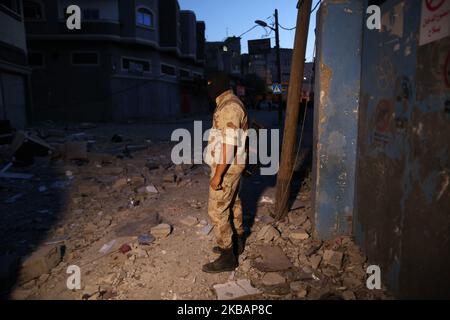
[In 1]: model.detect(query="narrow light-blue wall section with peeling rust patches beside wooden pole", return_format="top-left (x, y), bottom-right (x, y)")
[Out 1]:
top-left (313, 1), bottom-right (362, 239)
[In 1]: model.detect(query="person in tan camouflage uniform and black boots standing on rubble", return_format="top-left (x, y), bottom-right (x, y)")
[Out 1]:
top-left (203, 74), bottom-right (248, 273)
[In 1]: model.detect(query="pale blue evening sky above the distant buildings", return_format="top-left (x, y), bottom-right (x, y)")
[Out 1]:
top-left (178, 0), bottom-right (319, 61)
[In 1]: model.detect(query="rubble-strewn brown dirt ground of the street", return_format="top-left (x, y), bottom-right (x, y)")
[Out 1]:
top-left (0, 112), bottom-right (388, 300)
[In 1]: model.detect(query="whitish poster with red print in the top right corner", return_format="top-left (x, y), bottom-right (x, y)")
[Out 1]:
top-left (419, 0), bottom-right (450, 46)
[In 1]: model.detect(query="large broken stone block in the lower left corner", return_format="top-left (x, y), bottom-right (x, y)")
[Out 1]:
top-left (19, 246), bottom-right (62, 283)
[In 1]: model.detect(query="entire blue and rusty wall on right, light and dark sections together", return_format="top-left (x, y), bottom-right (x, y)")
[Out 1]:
top-left (313, 0), bottom-right (450, 298)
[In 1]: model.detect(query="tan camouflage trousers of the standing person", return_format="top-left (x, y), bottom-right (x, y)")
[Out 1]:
top-left (208, 167), bottom-right (244, 249)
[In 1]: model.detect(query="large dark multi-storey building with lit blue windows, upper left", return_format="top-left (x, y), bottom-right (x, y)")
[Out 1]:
top-left (24, 0), bottom-right (205, 121)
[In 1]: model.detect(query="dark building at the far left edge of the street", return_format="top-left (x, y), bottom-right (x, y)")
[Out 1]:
top-left (0, 0), bottom-right (31, 129)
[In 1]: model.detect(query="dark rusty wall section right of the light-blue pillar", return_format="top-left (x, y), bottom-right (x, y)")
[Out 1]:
top-left (355, 0), bottom-right (450, 298)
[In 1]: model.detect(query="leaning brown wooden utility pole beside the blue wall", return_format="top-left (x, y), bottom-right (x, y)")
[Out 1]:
top-left (275, 0), bottom-right (312, 220)
